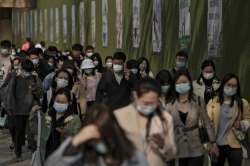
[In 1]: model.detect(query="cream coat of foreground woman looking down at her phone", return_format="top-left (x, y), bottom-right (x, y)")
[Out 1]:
top-left (115, 104), bottom-right (176, 166)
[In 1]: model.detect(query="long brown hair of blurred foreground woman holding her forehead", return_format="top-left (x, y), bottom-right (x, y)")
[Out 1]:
top-left (84, 104), bottom-right (135, 163)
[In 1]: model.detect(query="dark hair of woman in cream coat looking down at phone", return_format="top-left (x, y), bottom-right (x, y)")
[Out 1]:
top-left (135, 77), bottom-right (167, 139)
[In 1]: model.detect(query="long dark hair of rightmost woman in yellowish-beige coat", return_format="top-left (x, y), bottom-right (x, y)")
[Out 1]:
top-left (218, 73), bottom-right (243, 110)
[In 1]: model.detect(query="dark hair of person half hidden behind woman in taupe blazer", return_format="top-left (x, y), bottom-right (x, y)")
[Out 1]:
top-left (155, 69), bottom-right (173, 102)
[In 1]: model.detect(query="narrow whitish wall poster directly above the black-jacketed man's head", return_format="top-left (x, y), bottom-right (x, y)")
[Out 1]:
top-left (116, 0), bottom-right (123, 49)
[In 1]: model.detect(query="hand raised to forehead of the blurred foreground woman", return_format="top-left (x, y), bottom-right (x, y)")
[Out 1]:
top-left (72, 125), bottom-right (101, 147)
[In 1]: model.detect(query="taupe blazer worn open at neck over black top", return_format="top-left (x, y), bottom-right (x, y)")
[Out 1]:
top-left (167, 100), bottom-right (215, 158)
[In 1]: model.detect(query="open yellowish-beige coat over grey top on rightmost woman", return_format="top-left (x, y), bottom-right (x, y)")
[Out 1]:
top-left (207, 97), bottom-right (250, 148)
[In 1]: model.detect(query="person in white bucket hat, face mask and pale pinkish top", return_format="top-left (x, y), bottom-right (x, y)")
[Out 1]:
top-left (80, 59), bottom-right (101, 111)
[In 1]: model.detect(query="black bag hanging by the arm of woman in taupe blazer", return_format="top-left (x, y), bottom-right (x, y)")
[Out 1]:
top-left (198, 97), bottom-right (209, 144)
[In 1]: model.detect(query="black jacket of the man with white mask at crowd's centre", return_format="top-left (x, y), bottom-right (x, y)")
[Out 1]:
top-left (96, 71), bottom-right (131, 110)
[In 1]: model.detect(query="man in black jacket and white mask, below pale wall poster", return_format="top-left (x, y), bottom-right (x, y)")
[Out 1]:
top-left (96, 52), bottom-right (131, 110)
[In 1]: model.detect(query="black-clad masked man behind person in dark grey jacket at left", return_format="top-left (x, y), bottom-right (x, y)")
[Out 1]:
top-left (28, 48), bottom-right (54, 81)
